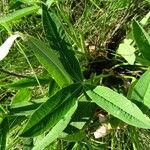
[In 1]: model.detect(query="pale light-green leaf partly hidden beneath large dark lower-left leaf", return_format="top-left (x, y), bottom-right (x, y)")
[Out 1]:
top-left (32, 102), bottom-right (78, 150)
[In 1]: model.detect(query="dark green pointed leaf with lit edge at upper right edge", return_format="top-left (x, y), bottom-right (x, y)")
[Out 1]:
top-left (133, 20), bottom-right (150, 60)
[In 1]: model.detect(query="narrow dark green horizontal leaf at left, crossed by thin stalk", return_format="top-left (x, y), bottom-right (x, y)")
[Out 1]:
top-left (0, 78), bottom-right (50, 89)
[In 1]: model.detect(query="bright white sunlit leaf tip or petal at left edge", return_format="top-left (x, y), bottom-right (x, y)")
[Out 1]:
top-left (0, 34), bottom-right (19, 60)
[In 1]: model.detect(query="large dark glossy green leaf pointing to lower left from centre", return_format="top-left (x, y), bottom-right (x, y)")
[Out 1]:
top-left (22, 84), bottom-right (81, 136)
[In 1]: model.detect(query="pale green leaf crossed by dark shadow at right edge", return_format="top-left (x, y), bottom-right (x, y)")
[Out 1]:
top-left (131, 69), bottom-right (150, 108)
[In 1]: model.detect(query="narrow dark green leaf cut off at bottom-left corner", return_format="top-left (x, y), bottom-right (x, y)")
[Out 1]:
top-left (0, 118), bottom-right (9, 150)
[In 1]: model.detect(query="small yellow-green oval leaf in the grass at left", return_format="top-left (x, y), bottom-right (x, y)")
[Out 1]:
top-left (11, 88), bottom-right (32, 106)
